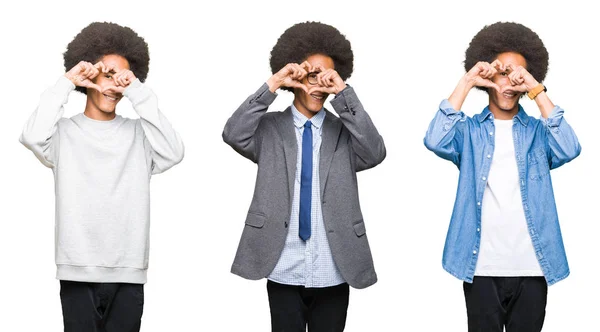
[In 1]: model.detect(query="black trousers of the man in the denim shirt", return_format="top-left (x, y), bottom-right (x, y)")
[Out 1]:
top-left (463, 277), bottom-right (548, 332)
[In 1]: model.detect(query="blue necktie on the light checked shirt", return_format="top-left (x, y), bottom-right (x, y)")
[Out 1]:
top-left (299, 121), bottom-right (312, 241)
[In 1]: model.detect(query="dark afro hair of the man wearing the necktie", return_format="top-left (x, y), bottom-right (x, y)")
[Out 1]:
top-left (270, 22), bottom-right (354, 91)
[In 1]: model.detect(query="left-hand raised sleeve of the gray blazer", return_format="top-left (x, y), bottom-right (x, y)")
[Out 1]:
top-left (223, 83), bottom-right (277, 163)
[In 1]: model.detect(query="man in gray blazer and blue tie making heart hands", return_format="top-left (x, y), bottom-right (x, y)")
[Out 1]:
top-left (223, 22), bottom-right (386, 331)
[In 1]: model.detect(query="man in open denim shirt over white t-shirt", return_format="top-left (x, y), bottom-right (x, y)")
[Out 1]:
top-left (425, 22), bottom-right (581, 332)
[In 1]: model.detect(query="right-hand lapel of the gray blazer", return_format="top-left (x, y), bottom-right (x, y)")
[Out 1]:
top-left (319, 111), bottom-right (342, 198)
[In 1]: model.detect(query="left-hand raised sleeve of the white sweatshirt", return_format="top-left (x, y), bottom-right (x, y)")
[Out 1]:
top-left (19, 76), bottom-right (75, 168)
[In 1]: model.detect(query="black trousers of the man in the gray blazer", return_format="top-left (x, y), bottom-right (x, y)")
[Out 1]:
top-left (267, 280), bottom-right (350, 332)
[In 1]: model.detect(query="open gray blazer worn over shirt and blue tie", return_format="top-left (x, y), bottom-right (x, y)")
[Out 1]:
top-left (223, 83), bottom-right (386, 288)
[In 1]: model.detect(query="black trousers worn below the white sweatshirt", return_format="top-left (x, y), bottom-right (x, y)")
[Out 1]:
top-left (60, 280), bottom-right (144, 332)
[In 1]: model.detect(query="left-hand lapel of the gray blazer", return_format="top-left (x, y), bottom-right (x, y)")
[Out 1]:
top-left (277, 107), bottom-right (298, 202)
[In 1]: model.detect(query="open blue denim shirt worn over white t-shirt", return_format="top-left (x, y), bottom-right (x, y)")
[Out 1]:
top-left (424, 100), bottom-right (581, 285)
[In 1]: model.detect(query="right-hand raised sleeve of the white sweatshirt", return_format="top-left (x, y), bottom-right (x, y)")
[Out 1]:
top-left (123, 79), bottom-right (184, 174)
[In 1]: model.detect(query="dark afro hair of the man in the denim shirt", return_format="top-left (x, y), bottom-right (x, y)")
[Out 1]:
top-left (465, 22), bottom-right (548, 91)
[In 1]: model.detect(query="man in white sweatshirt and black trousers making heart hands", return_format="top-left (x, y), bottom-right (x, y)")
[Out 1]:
top-left (20, 22), bottom-right (184, 331)
